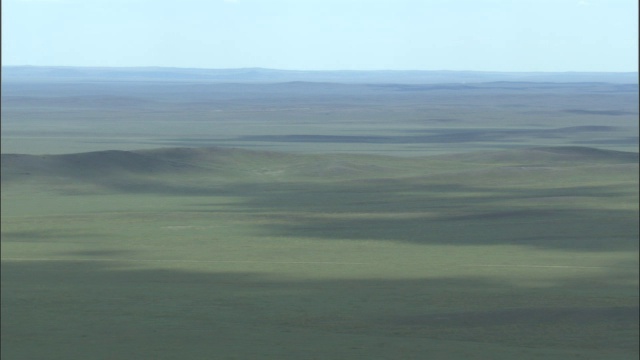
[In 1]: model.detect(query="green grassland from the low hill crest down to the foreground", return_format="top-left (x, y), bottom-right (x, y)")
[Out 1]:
top-left (2, 147), bottom-right (638, 359)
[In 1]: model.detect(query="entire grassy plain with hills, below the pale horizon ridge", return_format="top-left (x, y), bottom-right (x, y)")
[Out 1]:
top-left (2, 69), bottom-right (639, 359)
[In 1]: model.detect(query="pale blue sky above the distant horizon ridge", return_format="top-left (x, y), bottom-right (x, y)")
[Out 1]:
top-left (2, 0), bottom-right (638, 71)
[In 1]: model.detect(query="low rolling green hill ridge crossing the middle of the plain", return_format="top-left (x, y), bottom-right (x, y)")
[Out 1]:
top-left (1, 147), bottom-right (638, 184)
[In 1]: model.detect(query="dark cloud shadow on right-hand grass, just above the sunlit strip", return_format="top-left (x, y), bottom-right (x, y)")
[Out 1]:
top-left (255, 210), bottom-right (638, 251)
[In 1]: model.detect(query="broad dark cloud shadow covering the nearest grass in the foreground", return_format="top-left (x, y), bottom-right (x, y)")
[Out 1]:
top-left (2, 261), bottom-right (638, 359)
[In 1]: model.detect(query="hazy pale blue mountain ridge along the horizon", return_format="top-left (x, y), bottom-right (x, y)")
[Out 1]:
top-left (2, 66), bottom-right (638, 84)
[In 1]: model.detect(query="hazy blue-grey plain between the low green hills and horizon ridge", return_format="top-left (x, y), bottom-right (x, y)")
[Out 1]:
top-left (1, 81), bottom-right (638, 156)
